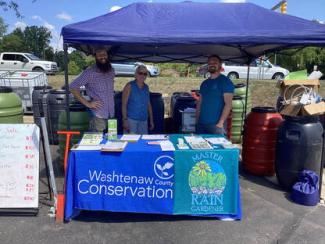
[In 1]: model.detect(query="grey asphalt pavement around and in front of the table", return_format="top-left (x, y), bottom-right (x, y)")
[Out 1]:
top-left (0, 146), bottom-right (325, 244)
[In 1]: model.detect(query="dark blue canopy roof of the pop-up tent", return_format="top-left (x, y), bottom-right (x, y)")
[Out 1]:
top-left (62, 2), bottom-right (325, 63)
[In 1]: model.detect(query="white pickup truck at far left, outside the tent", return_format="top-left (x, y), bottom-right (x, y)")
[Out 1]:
top-left (0, 52), bottom-right (59, 74)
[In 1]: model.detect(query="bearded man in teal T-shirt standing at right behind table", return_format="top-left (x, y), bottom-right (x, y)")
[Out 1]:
top-left (196, 55), bottom-right (234, 135)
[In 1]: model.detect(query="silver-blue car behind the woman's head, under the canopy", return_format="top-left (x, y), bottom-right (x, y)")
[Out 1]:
top-left (112, 62), bottom-right (160, 77)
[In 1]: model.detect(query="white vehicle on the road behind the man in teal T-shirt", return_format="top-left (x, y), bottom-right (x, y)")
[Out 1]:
top-left (197, 59), bottom-right (289, 80)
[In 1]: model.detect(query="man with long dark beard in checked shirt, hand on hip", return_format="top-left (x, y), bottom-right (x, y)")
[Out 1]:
top-left (70, 47), bottom-right (115, 132)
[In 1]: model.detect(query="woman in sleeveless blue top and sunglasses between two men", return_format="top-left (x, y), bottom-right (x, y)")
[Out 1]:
top-left (122, 65), bottom-right (154, 134)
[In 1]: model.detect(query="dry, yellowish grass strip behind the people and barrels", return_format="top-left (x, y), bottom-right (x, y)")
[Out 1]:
top-left (48, 75), bottom-right (325, 116)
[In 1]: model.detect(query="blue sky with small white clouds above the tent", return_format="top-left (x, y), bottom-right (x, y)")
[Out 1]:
top-left (0, 0), bottom-right (325, 49)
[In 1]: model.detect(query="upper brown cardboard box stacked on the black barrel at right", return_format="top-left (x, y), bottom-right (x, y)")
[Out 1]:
top-left (277, 80), bottom-right (320, 99)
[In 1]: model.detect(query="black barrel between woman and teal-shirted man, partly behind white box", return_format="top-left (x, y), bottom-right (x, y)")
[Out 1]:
top-left (170, 92), bottom-right (196, 133)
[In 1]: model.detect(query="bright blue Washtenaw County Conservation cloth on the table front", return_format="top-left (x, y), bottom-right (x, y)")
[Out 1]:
top-left (65, 138), bottom-right (174, 220)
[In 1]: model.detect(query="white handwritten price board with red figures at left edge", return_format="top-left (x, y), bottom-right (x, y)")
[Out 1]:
top-left (0, 124), bottom-right (40, 208)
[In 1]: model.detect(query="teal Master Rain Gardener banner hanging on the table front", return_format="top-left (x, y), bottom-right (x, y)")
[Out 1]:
top-left (174, 149), bottom-right (239, 215)
